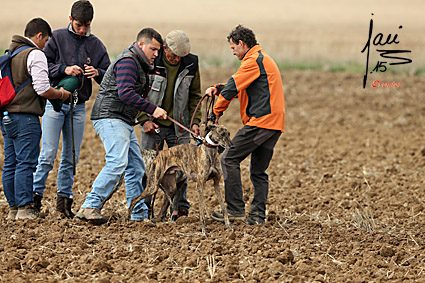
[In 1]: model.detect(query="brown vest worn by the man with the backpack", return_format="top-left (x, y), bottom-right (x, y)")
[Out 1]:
top-left (4, 35), bottom-right (46, 116)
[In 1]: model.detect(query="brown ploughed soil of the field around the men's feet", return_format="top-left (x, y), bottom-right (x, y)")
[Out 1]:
top-left (0, 70), bottom-right (425, 282)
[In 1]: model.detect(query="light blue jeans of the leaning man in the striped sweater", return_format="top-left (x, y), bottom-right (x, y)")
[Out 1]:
top-left (82, 119), bottom-right (148, 221)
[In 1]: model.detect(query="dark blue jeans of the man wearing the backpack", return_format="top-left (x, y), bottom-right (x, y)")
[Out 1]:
top-left (1, 113), bottom-right (41, 207)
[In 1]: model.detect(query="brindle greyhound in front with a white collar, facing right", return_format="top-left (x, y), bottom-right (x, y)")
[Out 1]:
top-left (128, 125), bottom-right (232, 234)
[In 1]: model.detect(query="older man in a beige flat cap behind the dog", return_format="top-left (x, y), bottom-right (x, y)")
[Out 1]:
top-left (138, 30), bottom-right (202, 220)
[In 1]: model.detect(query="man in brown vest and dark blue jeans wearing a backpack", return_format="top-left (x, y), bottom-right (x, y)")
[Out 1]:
top-left (1, 18), bottom-right (71, 219)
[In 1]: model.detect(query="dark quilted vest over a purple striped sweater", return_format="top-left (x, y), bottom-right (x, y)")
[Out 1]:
top-left (90, 46), bottom-right (149, 126)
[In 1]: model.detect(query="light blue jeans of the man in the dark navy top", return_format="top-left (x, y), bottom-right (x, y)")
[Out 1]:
top-left (33, 102), bottom-right (86, 198)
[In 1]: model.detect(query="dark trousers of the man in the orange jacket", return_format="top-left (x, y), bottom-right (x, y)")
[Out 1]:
top-left (221, 126), bottom-right (281, 219)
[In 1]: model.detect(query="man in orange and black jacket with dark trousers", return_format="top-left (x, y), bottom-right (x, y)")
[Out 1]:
top-left (206, 25), bottom-right (285, 225)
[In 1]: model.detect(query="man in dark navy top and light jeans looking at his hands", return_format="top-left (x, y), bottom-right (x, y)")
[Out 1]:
top-left (34, 0), bottom-right (110, 218)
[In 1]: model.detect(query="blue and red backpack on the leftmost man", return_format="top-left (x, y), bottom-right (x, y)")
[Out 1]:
top-left (0, 46), bottom-right (31, 107)
